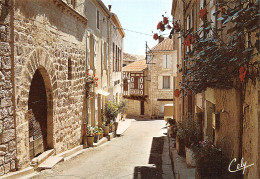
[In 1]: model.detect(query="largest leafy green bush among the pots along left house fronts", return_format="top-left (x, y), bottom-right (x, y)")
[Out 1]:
top-left (104, 101), bottom-right (118, 125)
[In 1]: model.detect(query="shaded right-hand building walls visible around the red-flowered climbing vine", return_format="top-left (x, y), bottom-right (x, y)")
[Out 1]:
top-left (172, 0), bottom-right (260, 178)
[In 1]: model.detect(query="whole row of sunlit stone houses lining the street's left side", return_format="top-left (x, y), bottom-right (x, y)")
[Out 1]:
top-left (0, 0), bottom-right (124, 175)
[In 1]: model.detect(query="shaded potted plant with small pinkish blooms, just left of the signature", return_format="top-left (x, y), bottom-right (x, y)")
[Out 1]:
top-left (193, 140), bottom-right (227, 179)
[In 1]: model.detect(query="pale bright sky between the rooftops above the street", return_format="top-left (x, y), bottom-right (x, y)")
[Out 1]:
top-left (102, 0), bottom-right (172, 55)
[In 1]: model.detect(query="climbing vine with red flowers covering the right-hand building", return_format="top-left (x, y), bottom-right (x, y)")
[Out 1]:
top-left (154, 0), bottom-right (260, 95)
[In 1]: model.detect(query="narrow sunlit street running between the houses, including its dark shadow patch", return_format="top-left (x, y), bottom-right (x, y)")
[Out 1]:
top-left (33, 119), bottom-right (172, 179)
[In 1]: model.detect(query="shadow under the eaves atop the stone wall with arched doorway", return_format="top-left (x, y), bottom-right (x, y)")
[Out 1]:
top-left (15, 0), bottom-right (86, 41)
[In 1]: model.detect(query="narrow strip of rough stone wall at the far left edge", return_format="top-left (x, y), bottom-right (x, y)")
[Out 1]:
top-left (0, 0), bottom-right (16, 175)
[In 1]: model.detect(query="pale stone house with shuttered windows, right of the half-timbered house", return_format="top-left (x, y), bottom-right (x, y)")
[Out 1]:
top-left (147, 38), bottom-right (176, 118)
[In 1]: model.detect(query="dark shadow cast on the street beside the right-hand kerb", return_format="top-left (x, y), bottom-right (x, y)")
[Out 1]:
top-left (133, 137), bottom-right (164, 179)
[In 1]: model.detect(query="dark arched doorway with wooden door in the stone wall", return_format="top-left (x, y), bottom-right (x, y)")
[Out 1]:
top-left (28, 67), bottom-right (53, 159)
